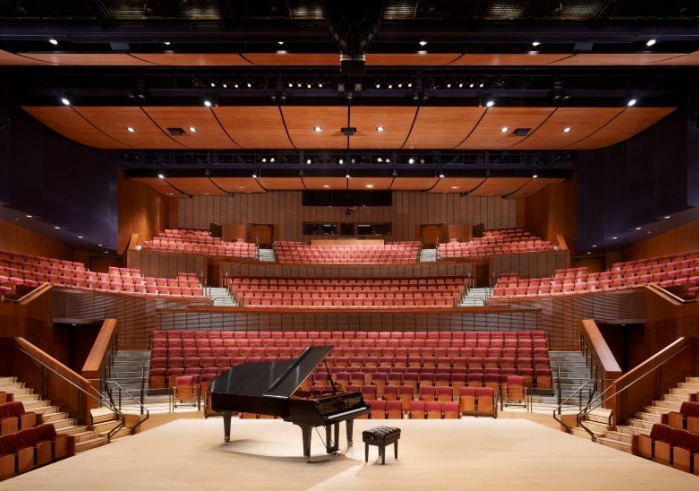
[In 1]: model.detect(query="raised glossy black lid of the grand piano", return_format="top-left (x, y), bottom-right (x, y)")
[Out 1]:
top-left (211, 346), bottom-right (333, 397)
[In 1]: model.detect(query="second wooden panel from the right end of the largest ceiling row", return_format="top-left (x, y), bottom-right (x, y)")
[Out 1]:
top-left (510, 107), bottom-right (624, 150)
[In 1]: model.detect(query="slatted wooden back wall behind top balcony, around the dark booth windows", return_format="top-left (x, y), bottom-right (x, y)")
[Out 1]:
top-left (171, 191), bottom-right (517, 241)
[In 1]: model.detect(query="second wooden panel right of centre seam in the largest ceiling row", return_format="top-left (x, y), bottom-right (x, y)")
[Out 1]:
top-left (403, 106), bottom-right (485, 149)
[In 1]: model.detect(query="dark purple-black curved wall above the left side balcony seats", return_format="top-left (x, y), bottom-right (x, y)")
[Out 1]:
top-left (0, 79), bottom-right (118, 252)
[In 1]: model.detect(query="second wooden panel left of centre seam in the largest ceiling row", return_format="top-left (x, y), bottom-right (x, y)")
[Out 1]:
top-left (213, 106), bottom-right (294, 150)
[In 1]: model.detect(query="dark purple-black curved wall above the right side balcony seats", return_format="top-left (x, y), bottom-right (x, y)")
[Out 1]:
top-left (577, 108), bottom-right (688, 252)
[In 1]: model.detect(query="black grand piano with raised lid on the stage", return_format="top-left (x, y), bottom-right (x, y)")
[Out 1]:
top-left (210, 346), bottom-right (369, 462)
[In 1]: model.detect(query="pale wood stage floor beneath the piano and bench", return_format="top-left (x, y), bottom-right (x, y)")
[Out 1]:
top-left (0, 418), bottom-right (699, 491)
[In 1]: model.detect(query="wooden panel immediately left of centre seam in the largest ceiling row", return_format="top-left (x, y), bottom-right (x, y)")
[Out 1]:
top-left (281, 106), bottom-right (350, 149)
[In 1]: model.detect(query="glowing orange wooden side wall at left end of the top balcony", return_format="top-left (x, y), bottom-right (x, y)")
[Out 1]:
top-left (117, 174), bottom-right (171, 253)
